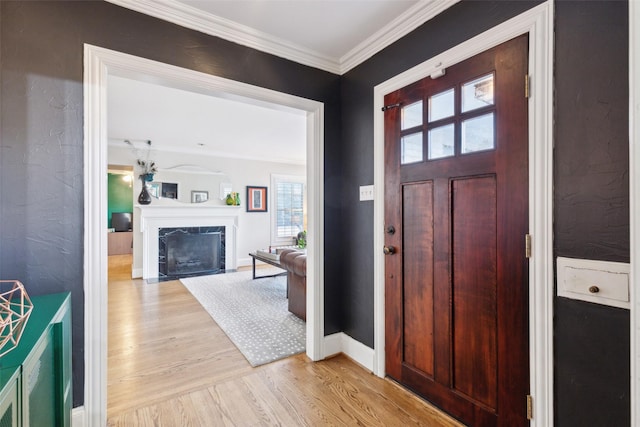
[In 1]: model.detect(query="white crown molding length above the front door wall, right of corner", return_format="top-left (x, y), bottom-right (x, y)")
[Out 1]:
top-left (339, 0), bottom-right (460, 74)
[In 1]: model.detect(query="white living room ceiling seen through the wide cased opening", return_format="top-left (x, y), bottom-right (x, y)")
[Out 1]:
top-left (107, 76), bottom-right (307, 164)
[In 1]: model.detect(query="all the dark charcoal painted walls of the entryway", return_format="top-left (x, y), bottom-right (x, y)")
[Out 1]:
top-left (0, 1), bottom-right (629, 426)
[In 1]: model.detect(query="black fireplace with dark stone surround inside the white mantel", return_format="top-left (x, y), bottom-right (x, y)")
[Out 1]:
top-left (158, 226), bottom-right (225, 279)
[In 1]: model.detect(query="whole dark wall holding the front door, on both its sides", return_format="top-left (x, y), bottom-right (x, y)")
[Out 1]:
top-left (341, 0), bottom-right (630, 426)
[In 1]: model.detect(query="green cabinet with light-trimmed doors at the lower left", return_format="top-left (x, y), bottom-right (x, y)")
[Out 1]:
top-left (0, 292), bottom-right (73, 427)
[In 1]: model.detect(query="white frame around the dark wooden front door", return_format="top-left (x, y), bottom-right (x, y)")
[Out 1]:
top-left (373, 1), bottom-right (553, 427)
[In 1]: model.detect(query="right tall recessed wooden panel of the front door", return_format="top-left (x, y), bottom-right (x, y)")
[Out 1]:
top-left (451, 176), bottom-right (498, 411)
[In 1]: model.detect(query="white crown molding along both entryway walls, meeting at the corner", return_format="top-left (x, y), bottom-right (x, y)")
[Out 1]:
top-left (107, 0), bottom-right (460, 74)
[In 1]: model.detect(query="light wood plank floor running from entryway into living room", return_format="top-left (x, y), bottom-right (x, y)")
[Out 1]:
top-left (107, 256), bottom-right (461, 427)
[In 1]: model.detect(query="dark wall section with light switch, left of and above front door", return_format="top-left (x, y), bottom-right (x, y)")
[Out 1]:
top-left (342, 1), bottom-right (540, 354)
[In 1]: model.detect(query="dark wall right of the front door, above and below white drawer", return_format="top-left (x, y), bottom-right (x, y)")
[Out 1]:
top-left (554, 1), bottom-right (630, 426)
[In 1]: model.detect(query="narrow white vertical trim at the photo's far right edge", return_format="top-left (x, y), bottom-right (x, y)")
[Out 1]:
top-left (629, 0), bottom-right (640, 426)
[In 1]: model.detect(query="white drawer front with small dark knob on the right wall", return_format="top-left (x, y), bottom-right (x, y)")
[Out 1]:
top-left (557, 257), bottom-right (630, 308)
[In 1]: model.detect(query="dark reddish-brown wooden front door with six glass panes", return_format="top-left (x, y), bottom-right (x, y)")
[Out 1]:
top-left (384, 36), bottom-right (529, 427)
